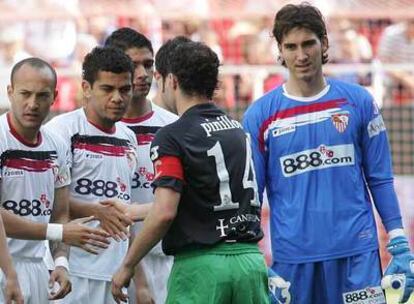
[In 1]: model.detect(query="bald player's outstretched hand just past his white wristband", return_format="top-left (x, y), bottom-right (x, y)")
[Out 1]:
top-left (62, 216), bottom-right (110, 254)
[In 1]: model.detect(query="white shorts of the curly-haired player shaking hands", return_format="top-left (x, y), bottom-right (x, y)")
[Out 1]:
top-left (61, 275), bottom-right (123, 304)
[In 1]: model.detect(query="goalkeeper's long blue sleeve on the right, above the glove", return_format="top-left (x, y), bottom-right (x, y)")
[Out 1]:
top-left (361, 93), bottom-right (402, 231)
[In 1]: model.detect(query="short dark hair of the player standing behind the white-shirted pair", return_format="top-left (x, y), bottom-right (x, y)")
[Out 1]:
top-left (105, 27), bottom-right (154, 55)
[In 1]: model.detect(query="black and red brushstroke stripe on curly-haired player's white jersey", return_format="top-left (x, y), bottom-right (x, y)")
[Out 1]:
top-left (71, 134), bottom-right (131, 156)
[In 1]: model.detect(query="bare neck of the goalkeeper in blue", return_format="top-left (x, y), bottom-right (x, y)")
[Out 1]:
top-left (285, 75), bottom-right (327, 97)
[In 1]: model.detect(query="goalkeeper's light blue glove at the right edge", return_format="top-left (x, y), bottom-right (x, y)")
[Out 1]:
top-left (384, 236), bottom-right (414, 303)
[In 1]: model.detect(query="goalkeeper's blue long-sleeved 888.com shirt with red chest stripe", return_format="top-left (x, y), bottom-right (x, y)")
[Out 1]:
top-left (243, 79), bottom-right (402, 263)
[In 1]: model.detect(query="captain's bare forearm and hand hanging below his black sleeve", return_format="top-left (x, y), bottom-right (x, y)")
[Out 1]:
top-left (112, 187), bottom-right (181, 301)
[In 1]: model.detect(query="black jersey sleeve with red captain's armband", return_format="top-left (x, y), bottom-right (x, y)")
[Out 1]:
top-left (150, 127), bottom-right (184, 193)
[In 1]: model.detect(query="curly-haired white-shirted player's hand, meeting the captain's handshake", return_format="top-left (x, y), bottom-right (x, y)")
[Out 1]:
top-left (95, 200), bottom-right (134, 241)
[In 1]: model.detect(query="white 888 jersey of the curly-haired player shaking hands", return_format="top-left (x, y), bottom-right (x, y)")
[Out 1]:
top-left (47, 108), bottom-right (137, 281)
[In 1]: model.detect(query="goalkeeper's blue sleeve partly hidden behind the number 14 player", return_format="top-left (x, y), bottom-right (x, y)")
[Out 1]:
top-left (243, 107), bottom-right (266, 203)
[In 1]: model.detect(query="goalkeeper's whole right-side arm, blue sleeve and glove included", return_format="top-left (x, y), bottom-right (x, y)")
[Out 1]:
top-left (361, 94), bottom-right (414, 303)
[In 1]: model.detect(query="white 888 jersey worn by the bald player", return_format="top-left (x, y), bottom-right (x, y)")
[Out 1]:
top-left (0, 114), bottom-right (70, 258)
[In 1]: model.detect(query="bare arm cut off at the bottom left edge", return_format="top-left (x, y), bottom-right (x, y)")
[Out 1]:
top-left (0, 216), bottom-right (23, 304)
